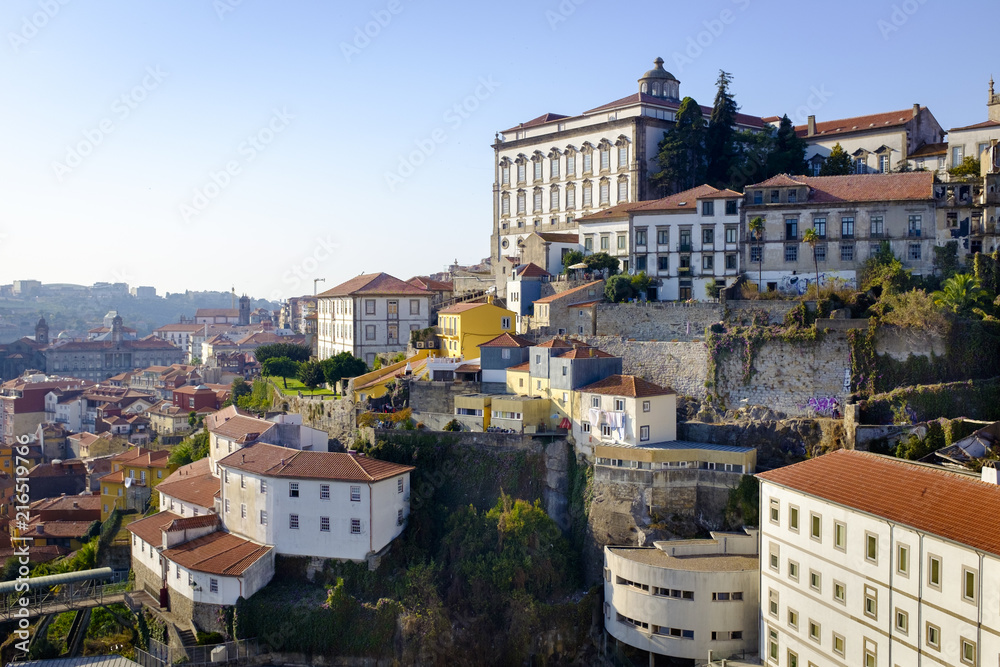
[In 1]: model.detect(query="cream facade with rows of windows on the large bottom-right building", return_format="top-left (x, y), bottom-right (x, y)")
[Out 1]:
top-left (760, 456), bottom-right (1000, 667)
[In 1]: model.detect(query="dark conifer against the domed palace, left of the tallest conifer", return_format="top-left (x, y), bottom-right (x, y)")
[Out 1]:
top-left (650, 97), bottom-right (706, 194)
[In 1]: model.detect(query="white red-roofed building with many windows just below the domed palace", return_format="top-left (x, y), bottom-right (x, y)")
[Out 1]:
top-left (579, 185), bottom-right (743, 301)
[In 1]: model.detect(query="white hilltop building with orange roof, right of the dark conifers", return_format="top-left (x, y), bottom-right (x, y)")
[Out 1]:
top-left (788, 104), bottom-right (945, 176)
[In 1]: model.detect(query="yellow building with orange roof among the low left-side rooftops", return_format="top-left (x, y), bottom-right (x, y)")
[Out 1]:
top-left (100, 447), bottom-right (177, 521)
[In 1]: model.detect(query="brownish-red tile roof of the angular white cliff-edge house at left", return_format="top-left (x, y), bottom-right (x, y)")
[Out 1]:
top-left (219, 443), bottom-right (414, 482)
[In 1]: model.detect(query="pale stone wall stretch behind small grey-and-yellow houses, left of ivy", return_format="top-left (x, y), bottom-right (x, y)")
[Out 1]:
top-left (582, 336), bottom-right (708, 398)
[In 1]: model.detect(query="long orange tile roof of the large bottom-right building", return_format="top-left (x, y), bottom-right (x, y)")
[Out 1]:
top-left (757, 449), bottom-right (1000, 555)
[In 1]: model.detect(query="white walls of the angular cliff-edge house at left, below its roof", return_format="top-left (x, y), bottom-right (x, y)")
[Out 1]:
top-left (220, 464), bottom-right (410, 561)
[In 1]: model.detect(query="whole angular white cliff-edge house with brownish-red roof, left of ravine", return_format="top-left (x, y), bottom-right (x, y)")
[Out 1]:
top-left (219, 443), bottom-right (413, 561)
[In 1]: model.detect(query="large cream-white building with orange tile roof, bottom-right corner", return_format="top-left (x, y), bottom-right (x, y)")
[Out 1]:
top-left (758, 450), bottom-right (1000, 667)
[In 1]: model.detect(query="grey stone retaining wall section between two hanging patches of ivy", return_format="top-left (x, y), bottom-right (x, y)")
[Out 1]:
top-left (717, 331), bottom-right (851, 415)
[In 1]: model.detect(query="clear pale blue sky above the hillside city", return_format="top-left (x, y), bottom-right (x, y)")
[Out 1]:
top-left (0, 0), bottom-right (1000, 299)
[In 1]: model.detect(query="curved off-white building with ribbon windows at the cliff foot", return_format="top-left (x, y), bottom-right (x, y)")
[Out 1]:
top-left (604, 530), bottom-right (756, 667)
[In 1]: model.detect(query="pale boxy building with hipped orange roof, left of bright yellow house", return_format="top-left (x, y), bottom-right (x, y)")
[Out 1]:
top-left (316, 273), bottom-right (432, 366)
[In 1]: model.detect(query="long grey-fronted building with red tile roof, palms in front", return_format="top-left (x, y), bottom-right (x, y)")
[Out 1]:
top-left (743, 172), bottom-right (936, 294)
